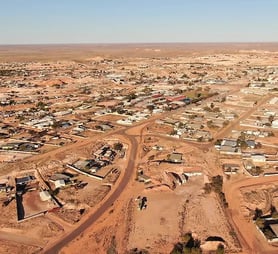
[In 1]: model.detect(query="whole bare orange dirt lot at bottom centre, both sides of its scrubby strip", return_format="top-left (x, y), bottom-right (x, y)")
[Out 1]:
top-left (129, 176), bottom-right (238, 253)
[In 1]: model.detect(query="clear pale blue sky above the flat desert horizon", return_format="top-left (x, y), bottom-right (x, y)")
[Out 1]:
top-left (0, 0), bottom-right (278, 44)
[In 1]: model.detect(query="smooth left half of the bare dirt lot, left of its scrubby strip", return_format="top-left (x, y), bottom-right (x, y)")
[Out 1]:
top-left (128, 190), bottom-right (183, 253)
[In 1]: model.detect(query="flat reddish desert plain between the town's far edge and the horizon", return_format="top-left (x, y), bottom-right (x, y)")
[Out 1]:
top-left (0, 43), bottom-right (278, 62)
